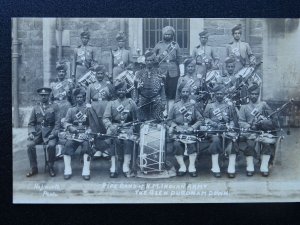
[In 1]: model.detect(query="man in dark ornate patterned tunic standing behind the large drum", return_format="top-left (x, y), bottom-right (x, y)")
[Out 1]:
top-left (136, 51), bottom-right (166, 120)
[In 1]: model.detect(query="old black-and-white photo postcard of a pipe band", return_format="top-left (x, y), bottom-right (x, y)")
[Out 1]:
top-left (11, 17), bottom-right (300, 204)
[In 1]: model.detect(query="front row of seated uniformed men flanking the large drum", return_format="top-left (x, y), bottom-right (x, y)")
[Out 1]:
top-left (27, 78), bottom-right (276, 180)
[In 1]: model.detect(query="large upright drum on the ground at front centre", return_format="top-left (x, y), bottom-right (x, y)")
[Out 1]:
top-left (138, 123), bottom-right (166, 174)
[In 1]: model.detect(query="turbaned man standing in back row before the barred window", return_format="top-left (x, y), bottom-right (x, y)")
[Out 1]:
top-left (153, 26), bottom-right (184, 108)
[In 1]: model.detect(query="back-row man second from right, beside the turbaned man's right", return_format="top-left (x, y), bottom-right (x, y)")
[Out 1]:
top-left (192, 31), bottom-right (219, 69)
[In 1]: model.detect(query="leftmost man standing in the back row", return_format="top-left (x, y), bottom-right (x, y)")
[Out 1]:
top-left (71, 31), bottom-right (96, 82)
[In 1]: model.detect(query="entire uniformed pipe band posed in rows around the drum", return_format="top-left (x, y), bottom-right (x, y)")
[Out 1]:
top-left (26, 25), bottom-right (278, 180)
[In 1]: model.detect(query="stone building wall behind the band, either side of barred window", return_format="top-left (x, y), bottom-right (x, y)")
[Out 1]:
top-left (14, 18), bottom-right (300, 124)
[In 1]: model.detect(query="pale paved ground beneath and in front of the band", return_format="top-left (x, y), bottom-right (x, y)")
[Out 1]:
top-left (13, 129), bottom-right (300, 203)
